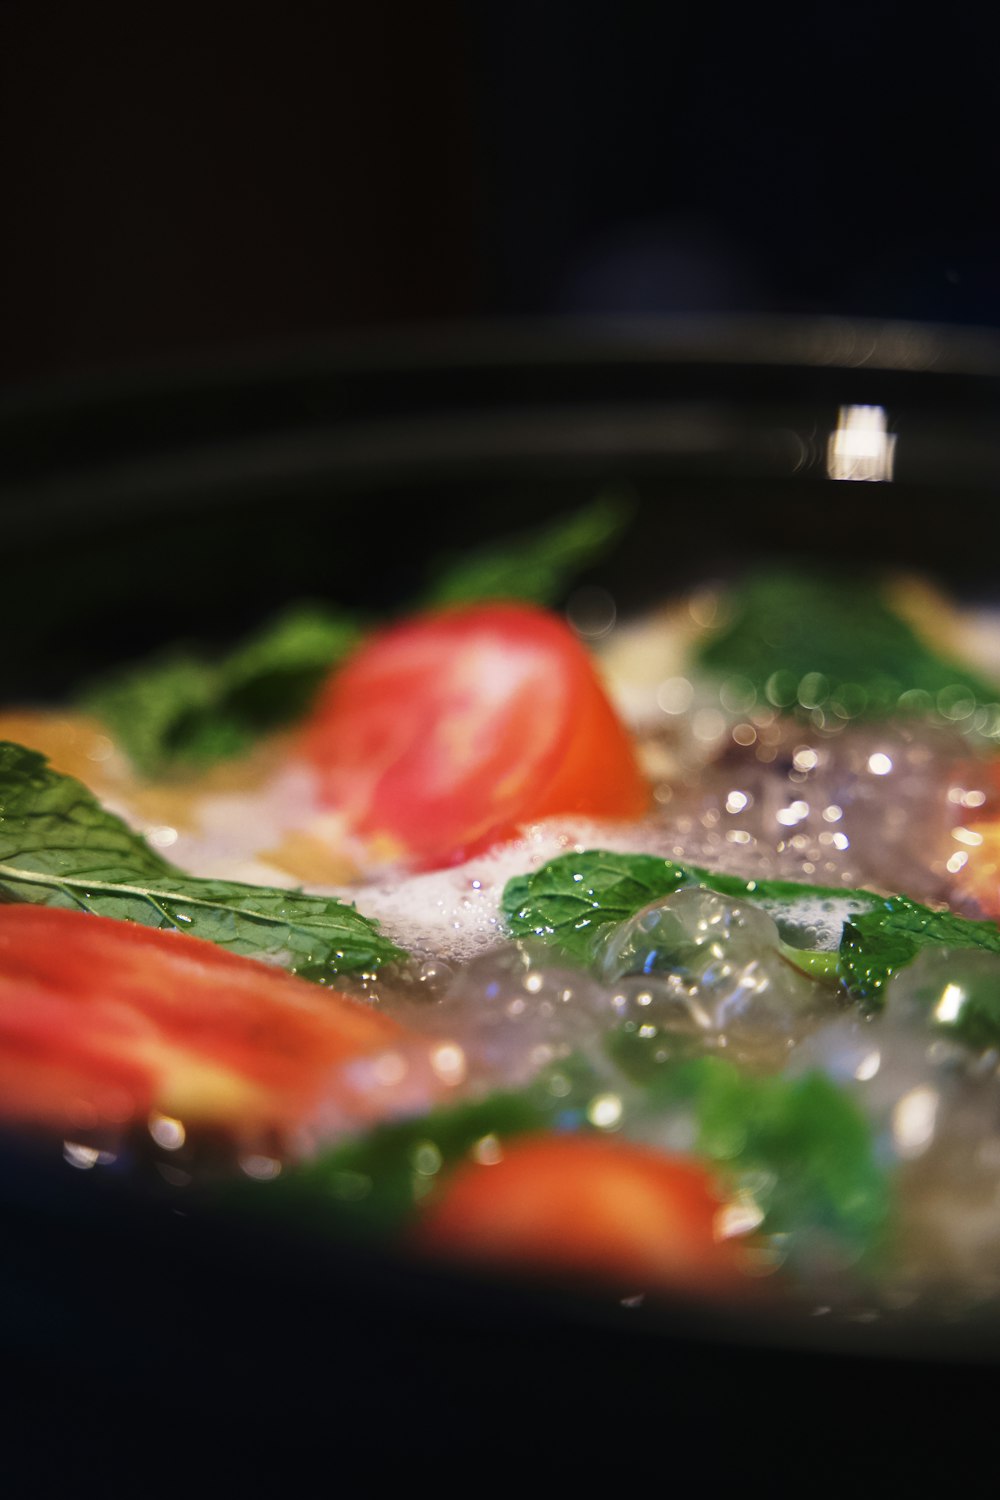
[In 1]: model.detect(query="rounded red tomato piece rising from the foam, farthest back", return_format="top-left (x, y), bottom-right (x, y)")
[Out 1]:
top-left (303, 603), bottom-right (649, 867)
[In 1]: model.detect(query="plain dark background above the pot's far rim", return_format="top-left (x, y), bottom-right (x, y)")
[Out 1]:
top-left (0, 0), bottom-right (1000, 384)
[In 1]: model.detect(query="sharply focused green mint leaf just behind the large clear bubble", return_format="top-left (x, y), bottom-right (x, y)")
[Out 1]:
top-left (502, 849), bottom-right (880, 965)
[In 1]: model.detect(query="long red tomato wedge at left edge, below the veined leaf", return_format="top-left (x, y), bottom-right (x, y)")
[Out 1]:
top-left (0, 906), bottom-right (406, 1134)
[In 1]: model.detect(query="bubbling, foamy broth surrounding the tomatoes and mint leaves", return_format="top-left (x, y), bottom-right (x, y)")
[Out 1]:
top-left (0, 567), bottom-right (1000, 1316)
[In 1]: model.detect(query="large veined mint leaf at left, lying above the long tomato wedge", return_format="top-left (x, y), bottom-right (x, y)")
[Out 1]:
top-left (0, 743), bottom-right (402, 983)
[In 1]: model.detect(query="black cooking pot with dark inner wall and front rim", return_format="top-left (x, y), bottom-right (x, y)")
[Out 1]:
top-left (0, 320), bottom-right (1000, 1494)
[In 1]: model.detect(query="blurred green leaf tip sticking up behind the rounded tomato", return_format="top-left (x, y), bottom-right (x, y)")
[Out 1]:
top-left (423, 495), bottom-right (633, 606)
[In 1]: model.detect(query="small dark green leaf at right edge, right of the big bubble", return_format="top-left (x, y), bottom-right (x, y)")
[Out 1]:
top-left (840, 896), bottom-right (1000, 1010)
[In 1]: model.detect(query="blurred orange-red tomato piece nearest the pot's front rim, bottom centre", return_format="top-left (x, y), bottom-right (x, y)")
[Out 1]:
top-left (417, 1136), bottom-right (748, 1295)
